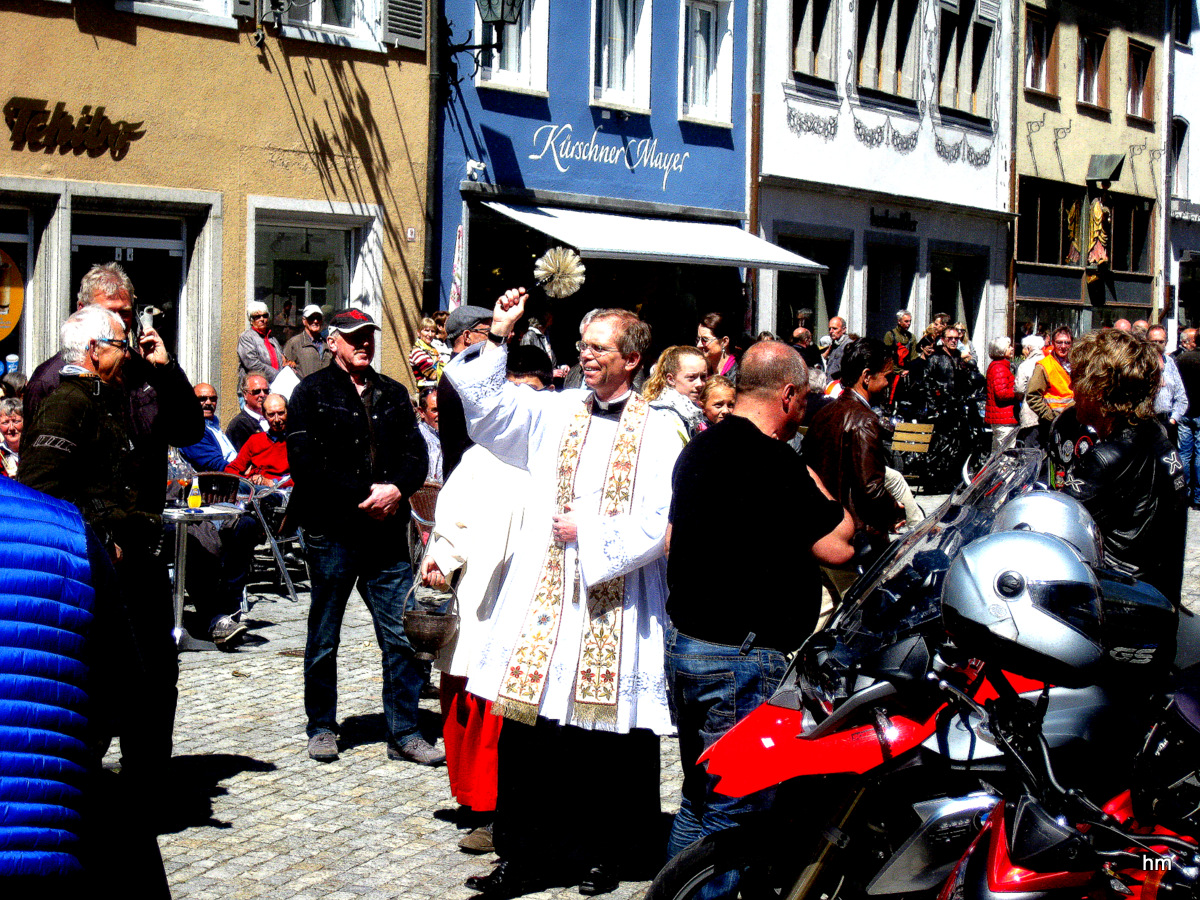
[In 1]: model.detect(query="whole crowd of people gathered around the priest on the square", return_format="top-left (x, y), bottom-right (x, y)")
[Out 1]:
top-left (0, 264), bottom-right (1200, 899)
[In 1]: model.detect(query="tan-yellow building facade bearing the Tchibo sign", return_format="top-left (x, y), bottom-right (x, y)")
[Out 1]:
top-left (0, 0), bottom-right (430, 415)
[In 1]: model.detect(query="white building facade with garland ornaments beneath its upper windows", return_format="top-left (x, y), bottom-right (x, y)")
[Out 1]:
top-left (757, 0), bottom-right (1014, 366)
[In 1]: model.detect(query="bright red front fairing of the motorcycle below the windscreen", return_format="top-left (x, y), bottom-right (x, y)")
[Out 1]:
top-left (700, 703), bottom-right (937, 797)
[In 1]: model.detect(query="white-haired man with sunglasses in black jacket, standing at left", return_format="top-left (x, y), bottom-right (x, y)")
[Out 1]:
top-left (18, 305), bottom-right (180, 791)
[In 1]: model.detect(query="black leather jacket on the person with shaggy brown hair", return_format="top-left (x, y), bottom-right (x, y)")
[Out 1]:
top-left (1050, 408), bottom-right (1188, 606)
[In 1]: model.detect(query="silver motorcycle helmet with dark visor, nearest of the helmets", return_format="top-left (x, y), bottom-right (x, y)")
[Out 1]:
top-left (942, 532), bottom-right (1104, 688)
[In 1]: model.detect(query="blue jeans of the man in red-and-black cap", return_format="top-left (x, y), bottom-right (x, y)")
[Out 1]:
top-left (304, 530), bottom-right (421, 748)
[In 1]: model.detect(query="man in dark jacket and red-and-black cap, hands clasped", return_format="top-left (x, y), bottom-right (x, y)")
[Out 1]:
top-left (288, 310), bottom-right (445, 766)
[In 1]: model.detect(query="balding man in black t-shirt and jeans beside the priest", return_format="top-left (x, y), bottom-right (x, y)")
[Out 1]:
top-left (666, 341), bottom-right (854, 856)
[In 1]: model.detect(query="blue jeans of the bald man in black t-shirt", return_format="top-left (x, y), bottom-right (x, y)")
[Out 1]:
top-left (666, 628), bottom-right (787, 857)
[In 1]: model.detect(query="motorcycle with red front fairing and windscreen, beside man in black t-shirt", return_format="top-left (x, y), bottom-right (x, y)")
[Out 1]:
top-left (647, 449), bottom-right (1195, 900)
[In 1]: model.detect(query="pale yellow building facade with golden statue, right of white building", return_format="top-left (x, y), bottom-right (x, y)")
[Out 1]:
top-left (1010, 0), bottom-right (1169, 335)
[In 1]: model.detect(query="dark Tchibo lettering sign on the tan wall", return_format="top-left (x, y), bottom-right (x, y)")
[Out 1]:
top-left (4, 97), bottom-right (145, 160)
